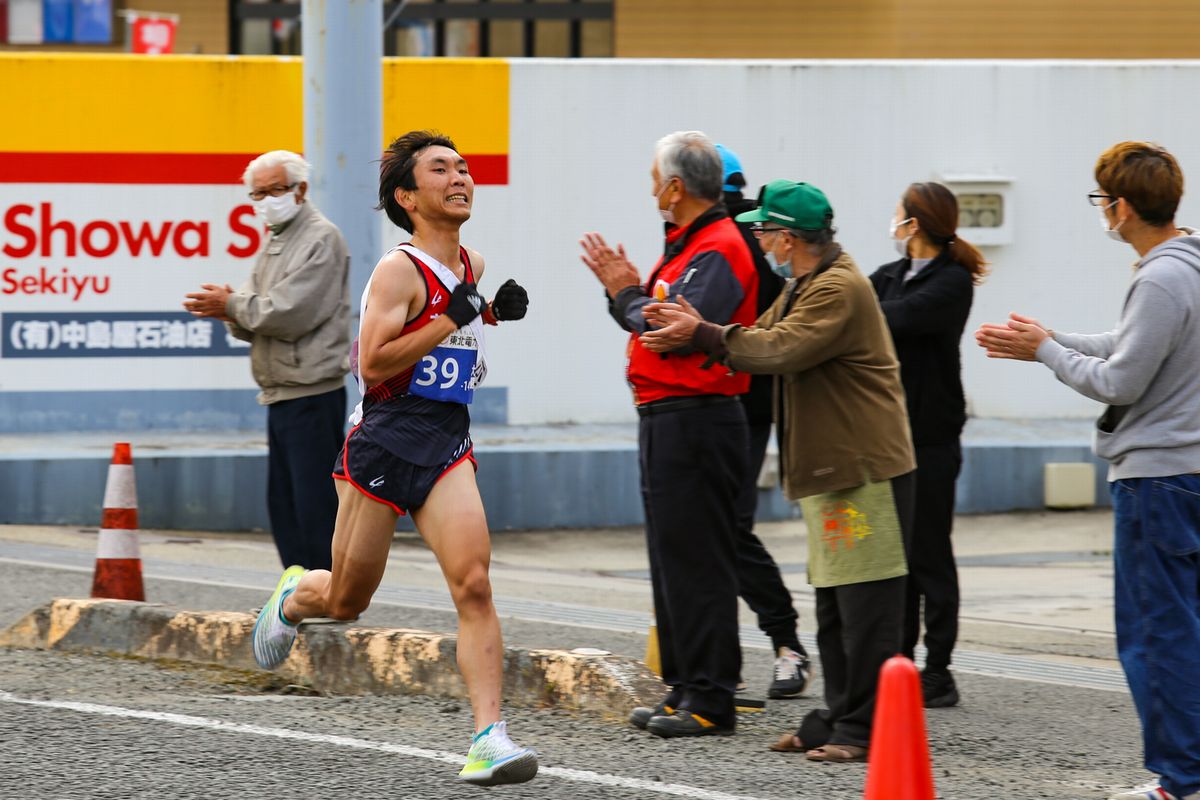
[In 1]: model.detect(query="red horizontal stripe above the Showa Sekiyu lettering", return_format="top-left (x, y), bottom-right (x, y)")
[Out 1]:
top-left (0, 152), bottom-right (509, 186)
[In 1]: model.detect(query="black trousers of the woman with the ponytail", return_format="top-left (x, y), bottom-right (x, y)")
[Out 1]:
top-left (902, 441), bottom-right (962, 670)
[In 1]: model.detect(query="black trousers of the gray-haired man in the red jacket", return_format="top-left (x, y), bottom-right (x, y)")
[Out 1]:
top-left (638, 401), bottom-right (749, 726)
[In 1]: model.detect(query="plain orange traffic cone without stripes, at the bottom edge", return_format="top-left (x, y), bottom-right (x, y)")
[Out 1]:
top-left (863, 656), bottom-right (935, 800)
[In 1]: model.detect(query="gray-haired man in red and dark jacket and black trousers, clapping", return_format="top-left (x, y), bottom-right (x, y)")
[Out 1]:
top-left (581, 131), bottom-right (758, 736)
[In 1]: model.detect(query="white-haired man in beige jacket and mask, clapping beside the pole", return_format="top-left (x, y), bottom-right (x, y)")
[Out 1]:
top-left (184, 150), bottom-right (350, 570)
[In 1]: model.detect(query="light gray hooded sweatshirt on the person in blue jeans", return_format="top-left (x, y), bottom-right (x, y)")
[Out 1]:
top-left (1037, 235), bottom-right (1200, 481)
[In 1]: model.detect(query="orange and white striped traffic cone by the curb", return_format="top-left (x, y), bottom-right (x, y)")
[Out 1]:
top-left (91, 441), bottom-right (146, 600)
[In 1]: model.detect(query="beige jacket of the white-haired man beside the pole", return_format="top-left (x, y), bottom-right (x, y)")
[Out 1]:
top-left (226, 201), bottom-right (350, 405)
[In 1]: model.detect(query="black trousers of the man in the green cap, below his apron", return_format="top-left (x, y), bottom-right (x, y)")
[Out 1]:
top-left (799, 473), bottom-right (916, 747)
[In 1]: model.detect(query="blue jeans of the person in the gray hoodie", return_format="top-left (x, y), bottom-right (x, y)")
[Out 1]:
top-left (1111, 475), bottom-right (1200, 798)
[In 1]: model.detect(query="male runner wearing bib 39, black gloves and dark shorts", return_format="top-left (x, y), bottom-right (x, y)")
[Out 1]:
top-left (254, 131), bottom-right (538, 786)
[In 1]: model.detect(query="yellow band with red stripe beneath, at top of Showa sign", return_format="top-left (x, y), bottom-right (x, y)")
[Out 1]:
top-left (0, 53), bottom-right (509, 184)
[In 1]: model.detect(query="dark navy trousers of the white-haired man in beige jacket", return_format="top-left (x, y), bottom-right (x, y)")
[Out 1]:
top-left (266, 389), bottom-right (346, 570)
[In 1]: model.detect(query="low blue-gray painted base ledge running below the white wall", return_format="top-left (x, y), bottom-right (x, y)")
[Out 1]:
top-left (0, 444), bottom-right (1109, 530)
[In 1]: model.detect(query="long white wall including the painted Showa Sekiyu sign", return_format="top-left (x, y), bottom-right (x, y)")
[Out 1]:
top-left (7, 56), bottom-right (1200, 431)
